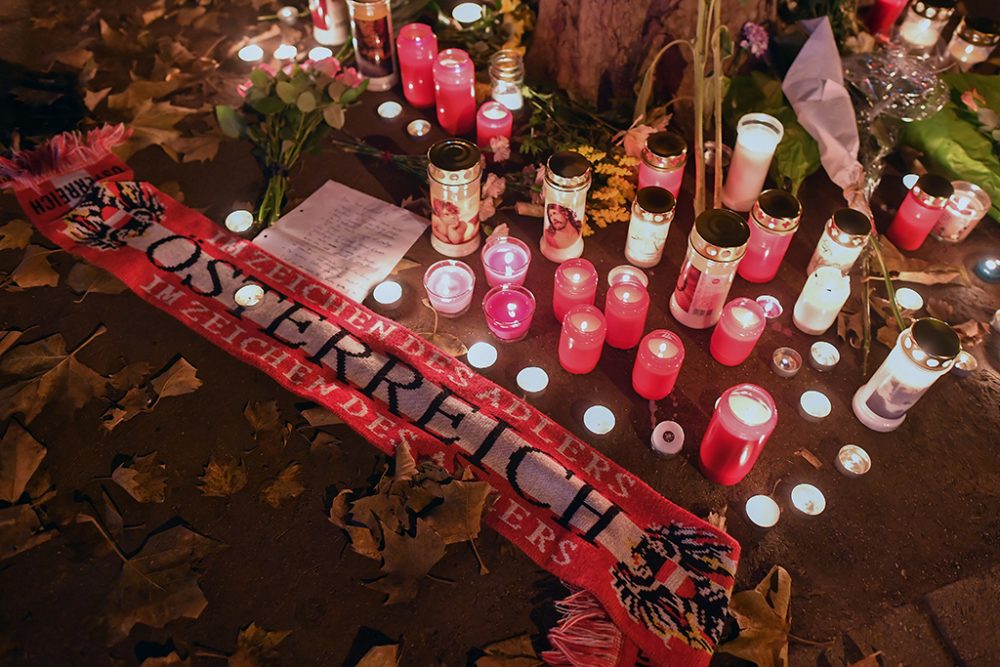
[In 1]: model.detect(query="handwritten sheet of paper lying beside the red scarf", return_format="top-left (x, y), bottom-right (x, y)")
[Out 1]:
top-left (254, 181), bottom-right (428, 302)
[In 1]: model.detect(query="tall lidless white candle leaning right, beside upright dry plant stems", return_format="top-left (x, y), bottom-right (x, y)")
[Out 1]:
top-left (722, 113), bottom-right (785, 211)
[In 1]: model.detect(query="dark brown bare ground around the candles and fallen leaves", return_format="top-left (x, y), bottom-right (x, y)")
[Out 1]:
top-left (0, 1), bottom-right (1000, 666)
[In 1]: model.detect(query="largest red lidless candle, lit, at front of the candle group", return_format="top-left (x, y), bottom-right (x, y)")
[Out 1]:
top-left (699, 384), bottom-right (778, 485)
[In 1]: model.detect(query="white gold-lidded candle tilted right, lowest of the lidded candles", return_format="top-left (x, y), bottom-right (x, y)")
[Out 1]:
top-left (852, 317), bottom-right (962, 432)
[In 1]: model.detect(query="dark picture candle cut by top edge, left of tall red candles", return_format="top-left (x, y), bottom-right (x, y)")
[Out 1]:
top-left (347, 0), bottom-right (390, 91)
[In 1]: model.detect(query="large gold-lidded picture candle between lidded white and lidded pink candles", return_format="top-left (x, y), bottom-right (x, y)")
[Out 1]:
top-left (670, 208), bottom-right (750, 329)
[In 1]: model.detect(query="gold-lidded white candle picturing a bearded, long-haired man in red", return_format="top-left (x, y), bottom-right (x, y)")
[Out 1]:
top-left (540, 151), bottom-right (591, 262)
